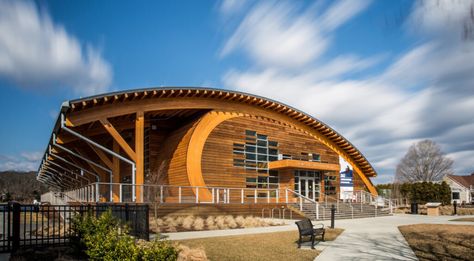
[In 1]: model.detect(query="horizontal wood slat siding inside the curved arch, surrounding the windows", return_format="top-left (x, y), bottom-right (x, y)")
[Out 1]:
top-left (202, 117), bottom-right (339, 196)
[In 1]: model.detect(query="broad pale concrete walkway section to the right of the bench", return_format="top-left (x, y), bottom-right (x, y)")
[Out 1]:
top-left (315, 215), bottom-right (474, 261)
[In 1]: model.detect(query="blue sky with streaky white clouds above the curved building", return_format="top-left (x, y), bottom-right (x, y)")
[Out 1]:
top-left (0, 0), bottom-right (474, 183)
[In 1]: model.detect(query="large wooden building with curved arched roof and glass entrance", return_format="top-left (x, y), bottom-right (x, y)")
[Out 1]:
top-left (37, 88), bottom-right (377, 203)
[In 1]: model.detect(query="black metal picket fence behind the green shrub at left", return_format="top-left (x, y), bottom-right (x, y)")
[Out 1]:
top-left (0, 203), bottom-right (149, 252)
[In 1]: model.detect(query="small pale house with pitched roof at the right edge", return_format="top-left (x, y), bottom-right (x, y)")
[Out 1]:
top-left (444, 173), bottom-right (474, 204)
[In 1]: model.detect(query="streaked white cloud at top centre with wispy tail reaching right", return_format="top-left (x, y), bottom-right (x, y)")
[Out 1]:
top-left (221, 1), bottom-right (368, 68)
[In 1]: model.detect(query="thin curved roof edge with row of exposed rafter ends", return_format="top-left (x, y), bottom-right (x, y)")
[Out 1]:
top-left (62, 87), bottom-right (377, 177)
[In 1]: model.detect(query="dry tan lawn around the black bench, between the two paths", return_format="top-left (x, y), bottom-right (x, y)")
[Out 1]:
top-left (179, 228), bottom-right (343, 261)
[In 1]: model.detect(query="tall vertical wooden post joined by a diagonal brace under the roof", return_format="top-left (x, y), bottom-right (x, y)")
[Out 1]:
top-left (135, 111), bottom-right (145, 203)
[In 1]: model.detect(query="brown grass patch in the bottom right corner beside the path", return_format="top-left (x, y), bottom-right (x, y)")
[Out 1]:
top-left (398, 221), bottom-right (474, 260)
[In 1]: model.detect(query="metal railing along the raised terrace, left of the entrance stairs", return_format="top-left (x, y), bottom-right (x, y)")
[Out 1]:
top-left (50, 182), bottom-right (302, 204)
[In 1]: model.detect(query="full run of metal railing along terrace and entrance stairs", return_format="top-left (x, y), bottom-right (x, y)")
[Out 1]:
top-left (47, 182), bottom-right (395, 214)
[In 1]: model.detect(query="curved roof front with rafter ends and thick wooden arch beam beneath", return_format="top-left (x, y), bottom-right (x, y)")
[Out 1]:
top-left (38, 87), bottom-right (377, 193)
